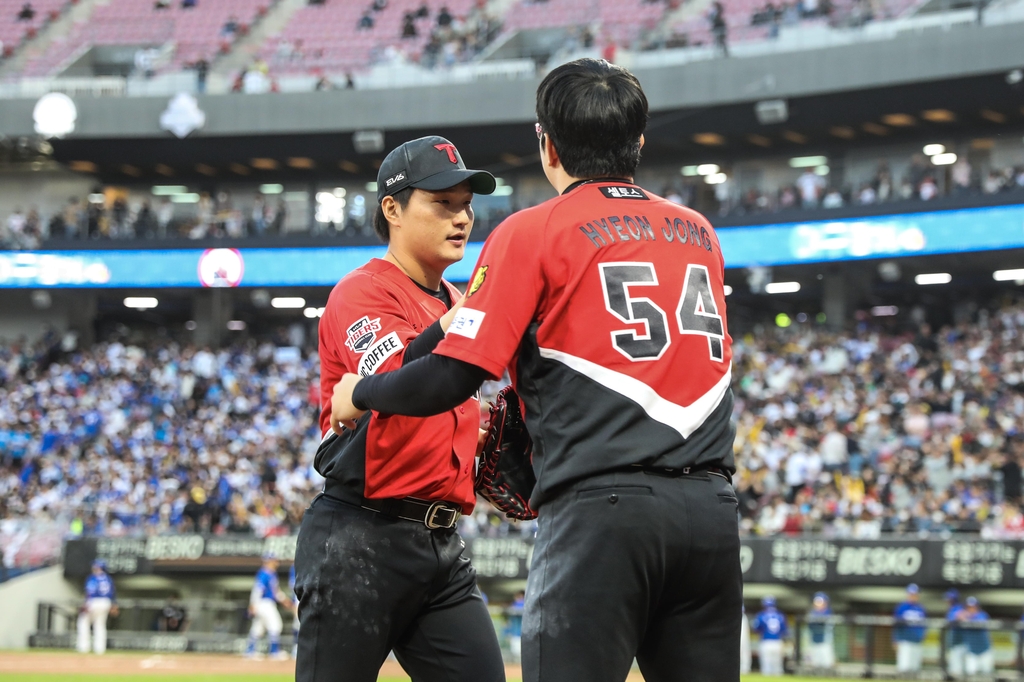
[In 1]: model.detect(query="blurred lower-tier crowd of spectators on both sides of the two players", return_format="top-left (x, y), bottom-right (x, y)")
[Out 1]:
top-left (0, 296), bottom-right (1024, 550)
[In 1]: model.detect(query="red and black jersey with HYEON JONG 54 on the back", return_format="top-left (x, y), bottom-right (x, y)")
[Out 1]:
top-left (434, 180), bottom-right (733, 505)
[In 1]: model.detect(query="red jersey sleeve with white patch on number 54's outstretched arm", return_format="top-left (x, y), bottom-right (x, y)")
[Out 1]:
top-left (434, 210), bottom-right (545, 379)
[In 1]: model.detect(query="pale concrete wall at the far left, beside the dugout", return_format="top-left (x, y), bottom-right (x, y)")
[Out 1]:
top-left (0, 566), bottom-right (82, 650)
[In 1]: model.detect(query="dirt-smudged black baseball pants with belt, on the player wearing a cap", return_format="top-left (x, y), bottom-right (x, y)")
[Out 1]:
top-left (295, 495), bottom-right (505, 682)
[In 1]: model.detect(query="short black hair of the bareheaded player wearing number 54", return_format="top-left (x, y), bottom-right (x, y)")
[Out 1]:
top-left (537, 57), bottom-right (647, 178)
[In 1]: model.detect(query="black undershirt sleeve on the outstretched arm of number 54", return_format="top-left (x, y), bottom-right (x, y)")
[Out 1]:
top-left (352, 344), bottom-right (488, 417)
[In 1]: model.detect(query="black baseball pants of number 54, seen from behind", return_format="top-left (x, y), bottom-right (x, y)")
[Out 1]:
top-left (522, 470), bottom-right (742, 682)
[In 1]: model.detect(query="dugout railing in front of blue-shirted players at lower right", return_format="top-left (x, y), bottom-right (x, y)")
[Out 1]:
top-left (790, 615), bottom-right (1024, 680)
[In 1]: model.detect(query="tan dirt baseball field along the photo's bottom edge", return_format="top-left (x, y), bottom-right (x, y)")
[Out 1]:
top-left (0, 651), bottom-right (824, 682)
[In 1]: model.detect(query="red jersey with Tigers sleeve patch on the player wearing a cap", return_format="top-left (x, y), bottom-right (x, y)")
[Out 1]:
top-left (317, 259), bottom-right (479, 513)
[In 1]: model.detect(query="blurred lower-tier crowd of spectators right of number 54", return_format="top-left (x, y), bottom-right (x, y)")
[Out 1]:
top-left (733, 305), bottom-right (1024, 538)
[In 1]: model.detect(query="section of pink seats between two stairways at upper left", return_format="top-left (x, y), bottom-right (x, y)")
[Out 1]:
top-left (24, 0), bottom-right (272, 76)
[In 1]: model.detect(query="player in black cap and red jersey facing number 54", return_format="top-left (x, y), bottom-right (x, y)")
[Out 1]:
top-left (295, 136), bottom-right (505, 682)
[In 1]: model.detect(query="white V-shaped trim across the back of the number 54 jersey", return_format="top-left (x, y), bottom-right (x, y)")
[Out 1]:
top-left (540, 348), bottom-right (732, 438)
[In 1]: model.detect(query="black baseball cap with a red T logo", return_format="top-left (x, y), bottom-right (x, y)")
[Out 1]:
top-left (377, 135), bottom-right (498, 204)
